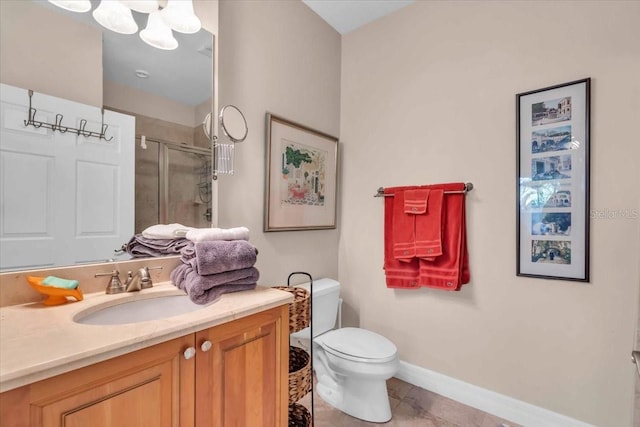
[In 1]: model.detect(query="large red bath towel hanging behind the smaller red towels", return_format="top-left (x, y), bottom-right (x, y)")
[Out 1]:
top-left (384, 183), bottom-right (470, 290)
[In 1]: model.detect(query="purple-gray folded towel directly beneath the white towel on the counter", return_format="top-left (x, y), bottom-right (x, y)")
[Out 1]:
top-left (180, 240), bottom-right (258, 276)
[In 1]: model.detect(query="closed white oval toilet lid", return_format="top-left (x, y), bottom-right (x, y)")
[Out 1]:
top-left (322, 328), bottom-right (397, 361)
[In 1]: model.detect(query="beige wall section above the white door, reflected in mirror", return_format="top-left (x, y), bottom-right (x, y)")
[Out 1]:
top-left (0, 0), bottom-right (102, 108)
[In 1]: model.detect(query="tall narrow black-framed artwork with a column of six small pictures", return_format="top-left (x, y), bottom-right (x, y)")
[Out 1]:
top-left (516, 78), bottom-right (591, 282)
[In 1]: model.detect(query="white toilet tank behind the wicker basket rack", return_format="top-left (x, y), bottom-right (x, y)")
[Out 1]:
top-left (296, 278), bottom-right (340, 337)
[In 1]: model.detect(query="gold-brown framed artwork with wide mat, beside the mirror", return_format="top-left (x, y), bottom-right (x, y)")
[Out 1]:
top-left (264, 113), bottom-right (338, 231)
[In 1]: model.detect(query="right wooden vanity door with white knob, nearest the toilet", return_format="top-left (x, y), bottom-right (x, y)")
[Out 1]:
top-left (195, 305), bottom-right (289, 427)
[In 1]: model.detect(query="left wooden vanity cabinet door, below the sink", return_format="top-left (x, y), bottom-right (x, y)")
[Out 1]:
top-left (0, 335), bottom-right (195, 427)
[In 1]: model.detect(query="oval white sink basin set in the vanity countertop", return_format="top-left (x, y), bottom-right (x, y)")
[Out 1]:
top-left (73, 295), bottom-right (207, 325)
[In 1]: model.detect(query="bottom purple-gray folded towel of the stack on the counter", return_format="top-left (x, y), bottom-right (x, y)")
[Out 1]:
top-left (171, 264), bottom-right (260, 304)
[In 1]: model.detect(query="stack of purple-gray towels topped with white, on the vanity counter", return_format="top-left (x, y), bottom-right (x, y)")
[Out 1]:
top-left (171, 227), bottom-right (260, 304)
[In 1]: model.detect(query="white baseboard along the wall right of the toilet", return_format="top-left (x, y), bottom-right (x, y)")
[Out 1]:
top-left (396, 361), bottom-right (594, 427)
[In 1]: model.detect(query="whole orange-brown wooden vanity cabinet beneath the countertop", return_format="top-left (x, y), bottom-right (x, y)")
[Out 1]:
top-left (0, 305), bottom-right (288, 427)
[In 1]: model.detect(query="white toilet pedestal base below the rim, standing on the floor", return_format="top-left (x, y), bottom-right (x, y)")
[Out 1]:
top-left (316, 376), bottom-right (391, 423)
